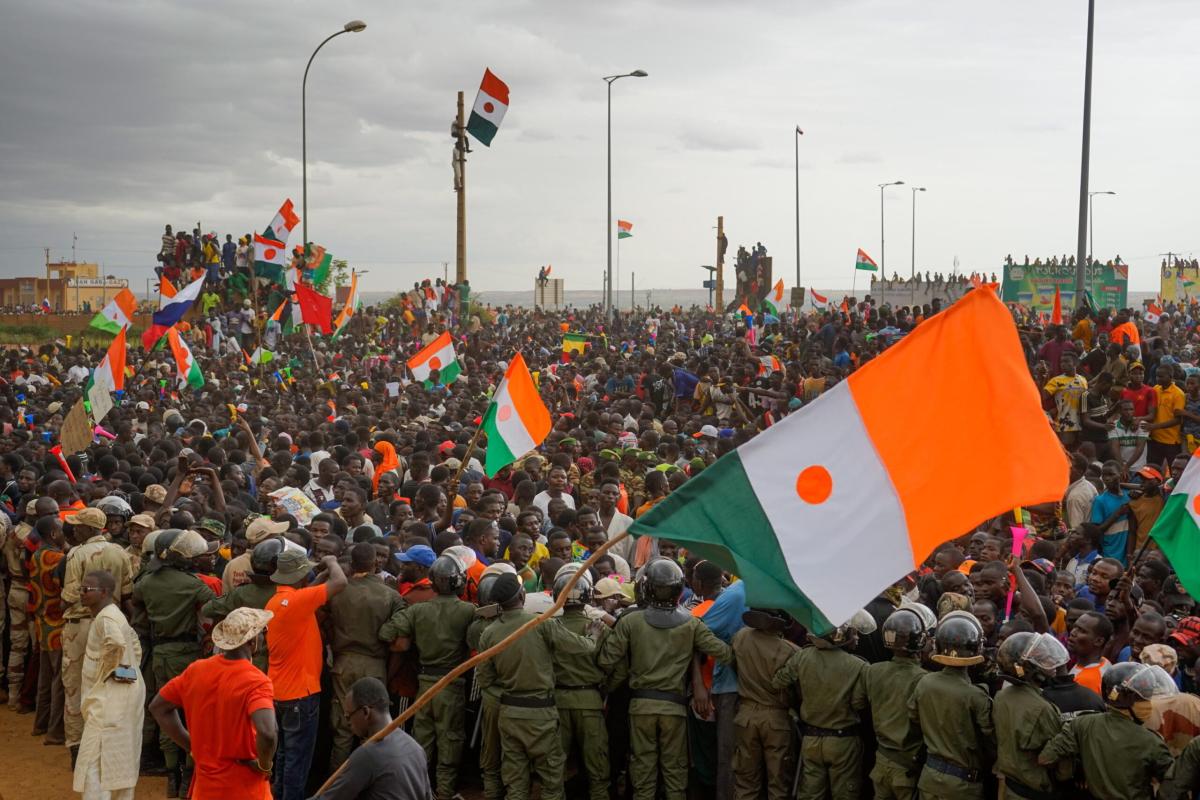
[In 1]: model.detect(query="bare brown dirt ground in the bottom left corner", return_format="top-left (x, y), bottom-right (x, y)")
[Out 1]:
top-left (0, 705), bottom-right (167, 800)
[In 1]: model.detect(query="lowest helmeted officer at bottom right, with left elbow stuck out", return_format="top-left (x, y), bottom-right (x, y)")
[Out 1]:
top-left (1038, 661), bottom-right (1174, 800)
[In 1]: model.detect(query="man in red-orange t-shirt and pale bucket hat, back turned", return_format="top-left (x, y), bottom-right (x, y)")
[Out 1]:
top-left (150, 608), bottom-right (277, 800)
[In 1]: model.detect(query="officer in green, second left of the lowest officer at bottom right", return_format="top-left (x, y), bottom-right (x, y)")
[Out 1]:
top-left (908, 612), bottom-right (996, 800)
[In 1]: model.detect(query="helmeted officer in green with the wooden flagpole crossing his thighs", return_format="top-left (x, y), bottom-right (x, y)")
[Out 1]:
top-left (379, 555), bottom-right (475, 800)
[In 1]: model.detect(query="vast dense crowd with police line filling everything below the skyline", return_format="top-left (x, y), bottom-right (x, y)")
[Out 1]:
top-left (0, 262), bottom-right (1200, 800)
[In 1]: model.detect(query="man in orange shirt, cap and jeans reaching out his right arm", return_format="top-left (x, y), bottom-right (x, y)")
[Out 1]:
top-left (266, 551), bottom-right (347, 800)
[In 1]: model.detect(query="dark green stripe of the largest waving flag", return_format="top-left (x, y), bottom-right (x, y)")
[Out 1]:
top-left (633, 447), bottom-right (833, 632)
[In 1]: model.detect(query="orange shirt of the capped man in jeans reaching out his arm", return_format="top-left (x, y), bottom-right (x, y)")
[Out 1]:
top-left (266, 583), bottom-right (329, 700)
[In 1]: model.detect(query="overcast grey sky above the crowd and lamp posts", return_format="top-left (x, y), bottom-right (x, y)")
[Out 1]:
top-left (0, 0), bottom-right (1200, 297)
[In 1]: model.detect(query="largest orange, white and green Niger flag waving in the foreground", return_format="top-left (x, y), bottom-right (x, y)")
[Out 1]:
top-left (630, 290), bottom-right (1067, 631)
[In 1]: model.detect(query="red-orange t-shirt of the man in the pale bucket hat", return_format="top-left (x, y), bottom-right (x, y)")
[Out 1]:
top-left (160, 656), bottom-right (275, 800)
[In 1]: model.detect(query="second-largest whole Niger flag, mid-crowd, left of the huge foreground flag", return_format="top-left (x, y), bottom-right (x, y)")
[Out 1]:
top-left (482, 353), bottom-right (550, 477)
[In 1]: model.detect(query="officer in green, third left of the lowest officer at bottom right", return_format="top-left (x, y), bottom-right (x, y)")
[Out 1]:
top-left (864, 606), bottom-right (937, 800)
